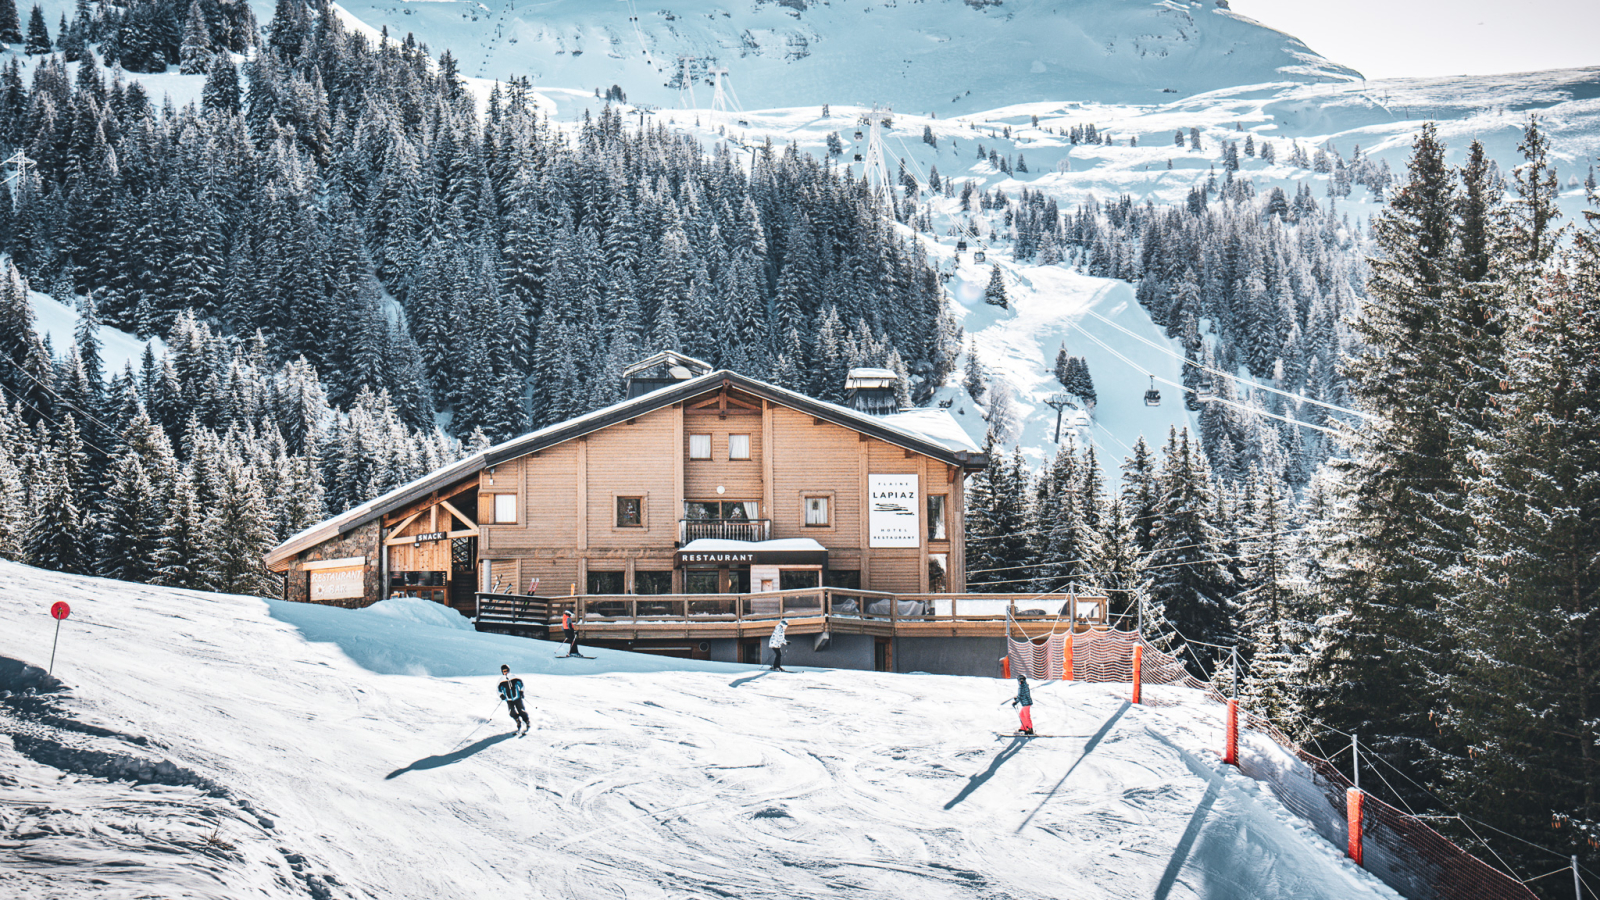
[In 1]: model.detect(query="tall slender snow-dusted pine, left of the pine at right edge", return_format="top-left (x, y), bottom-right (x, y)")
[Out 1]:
top-left (1307, 125), bottom-right (1467, 799)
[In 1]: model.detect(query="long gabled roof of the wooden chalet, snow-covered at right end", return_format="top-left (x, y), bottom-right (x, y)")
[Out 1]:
top-left (266, 370), bottom-right (989, 572)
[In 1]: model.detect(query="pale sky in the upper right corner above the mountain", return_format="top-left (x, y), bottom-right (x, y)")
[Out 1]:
top-left (1229, 0), bottom-right (1600, 78)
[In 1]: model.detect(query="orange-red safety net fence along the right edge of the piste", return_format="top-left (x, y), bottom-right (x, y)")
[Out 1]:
top-left (1006, 629), bottom-right (1536, 900)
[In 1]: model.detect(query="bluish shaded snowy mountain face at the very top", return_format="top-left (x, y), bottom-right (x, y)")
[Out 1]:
top-left (318, 0), bottom-right (1358, 114)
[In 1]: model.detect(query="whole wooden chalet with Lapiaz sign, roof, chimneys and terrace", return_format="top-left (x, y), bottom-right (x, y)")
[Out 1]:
top-left (266, 352), bottom-right (1104, 674)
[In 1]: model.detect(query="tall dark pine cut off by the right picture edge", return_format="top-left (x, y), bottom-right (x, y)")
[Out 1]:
top-left (1448, 187), bottom-right (1600, 871)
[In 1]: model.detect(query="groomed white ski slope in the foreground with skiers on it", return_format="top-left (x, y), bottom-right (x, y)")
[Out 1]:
top-left (0, 564), bottom-right (1394, 898)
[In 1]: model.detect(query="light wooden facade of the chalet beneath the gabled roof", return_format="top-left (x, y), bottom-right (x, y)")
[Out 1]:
top-left (267, 372), bottom-right (987, 615)
